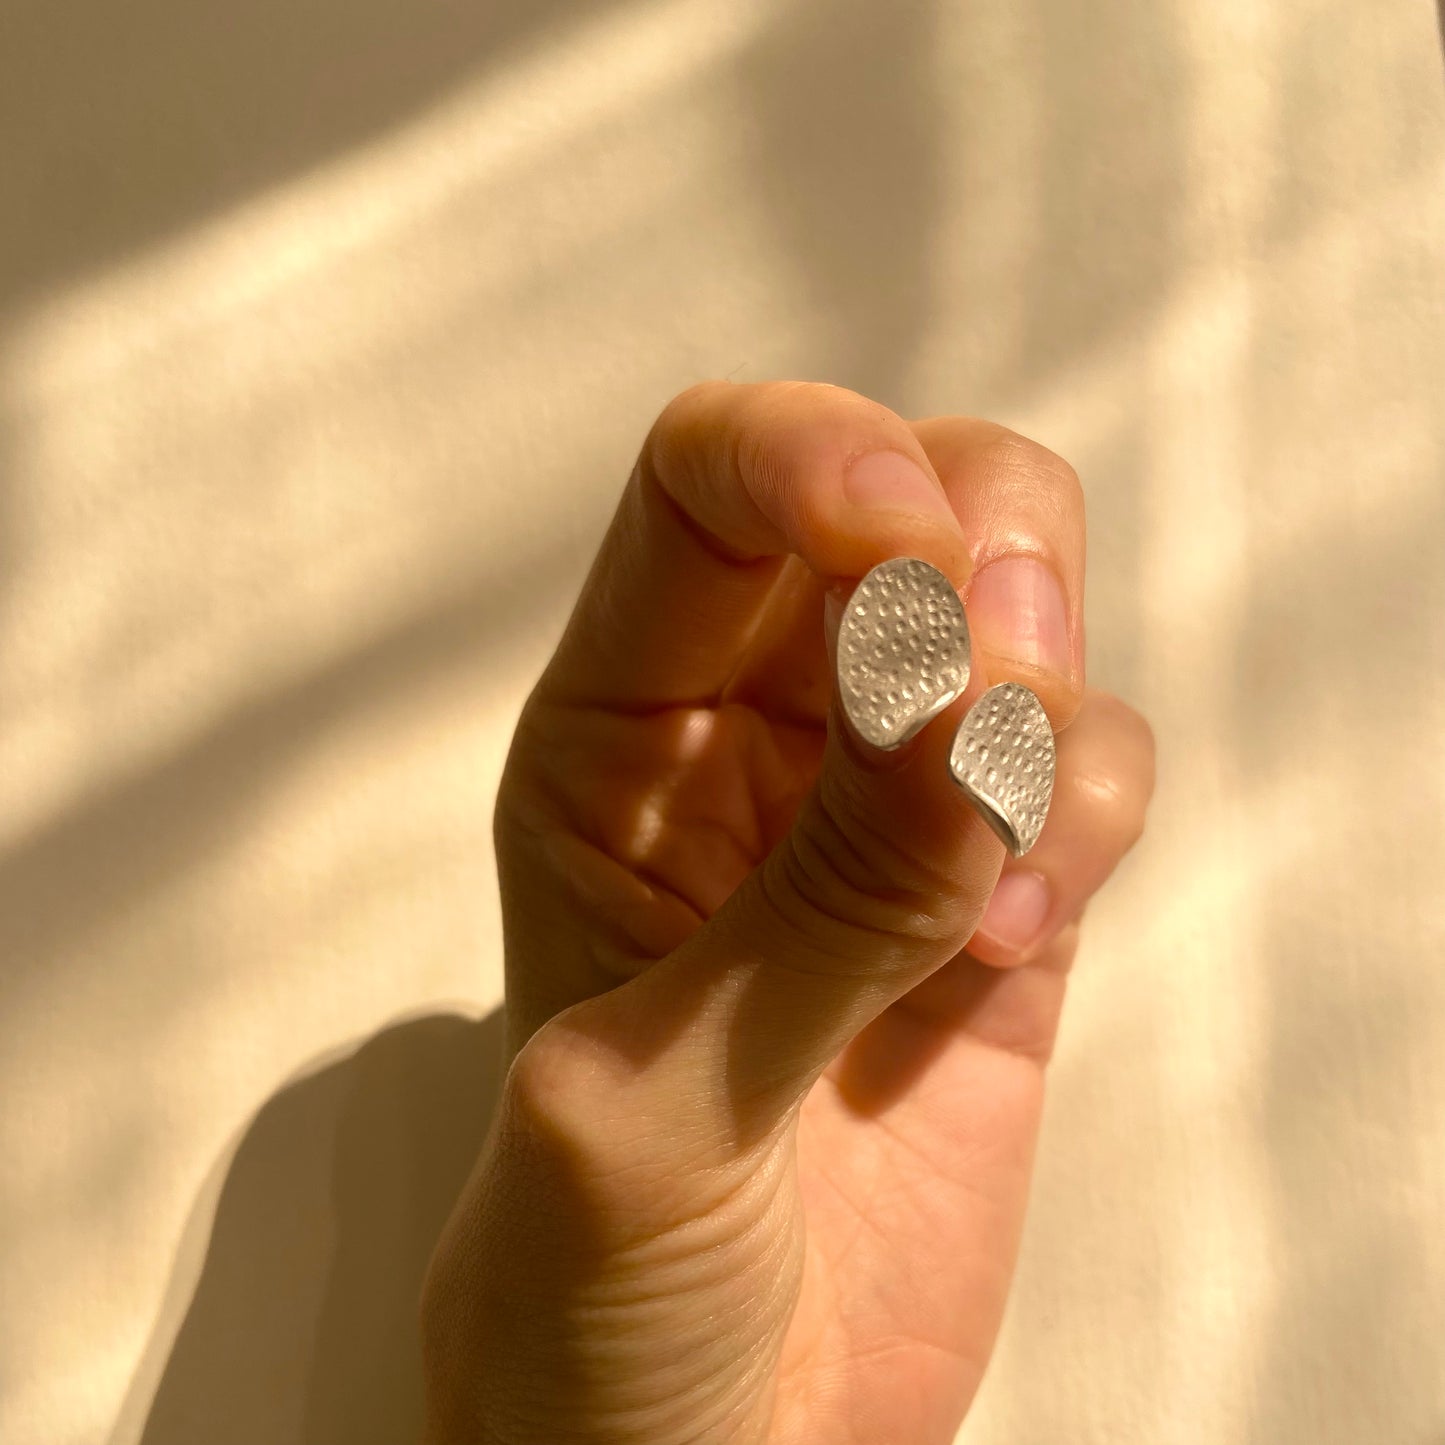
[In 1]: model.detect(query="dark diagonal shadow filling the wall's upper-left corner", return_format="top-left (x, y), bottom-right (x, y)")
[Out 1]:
top-left (0, 0), bottom-right (617, 318)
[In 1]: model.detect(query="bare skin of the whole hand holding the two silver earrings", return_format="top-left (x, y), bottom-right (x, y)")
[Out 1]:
top-left (422, 383), bottom-right (1153, 1445)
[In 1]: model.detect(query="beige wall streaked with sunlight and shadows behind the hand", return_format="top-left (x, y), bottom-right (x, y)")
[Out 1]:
top-left (0, 0), bottom-right (1445, 1445)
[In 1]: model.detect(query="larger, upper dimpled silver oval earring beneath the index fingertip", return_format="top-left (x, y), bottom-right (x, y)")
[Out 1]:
top-left (838, 556), bottom-right (970, 749)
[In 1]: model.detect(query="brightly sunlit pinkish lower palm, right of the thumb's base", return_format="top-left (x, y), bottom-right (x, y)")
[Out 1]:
top-left (779, 1016), bottom-right (1042, 1442)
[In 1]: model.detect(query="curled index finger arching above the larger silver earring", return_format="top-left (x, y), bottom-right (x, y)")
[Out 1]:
top-left (538, 381), bottom-right (970, 711)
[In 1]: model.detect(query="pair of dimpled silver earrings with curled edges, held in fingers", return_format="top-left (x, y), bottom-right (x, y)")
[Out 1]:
top-left (838, 556), bottom-right (1055, 858)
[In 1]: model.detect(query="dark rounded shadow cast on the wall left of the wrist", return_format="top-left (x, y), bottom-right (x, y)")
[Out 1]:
top-left (142, 1010), bottom-right (501, 1445)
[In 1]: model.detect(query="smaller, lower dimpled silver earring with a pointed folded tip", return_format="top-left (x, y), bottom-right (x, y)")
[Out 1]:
top-left (949, 682), bottom-right (1053, 857)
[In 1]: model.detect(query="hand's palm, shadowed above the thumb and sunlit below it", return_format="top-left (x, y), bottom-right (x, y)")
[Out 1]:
top-left (519, 623), bottom-right (1052, 1445)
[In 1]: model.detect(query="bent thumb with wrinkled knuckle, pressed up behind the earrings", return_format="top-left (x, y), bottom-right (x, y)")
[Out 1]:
top-left (553, 564), bottom-right (1003, 1150)
